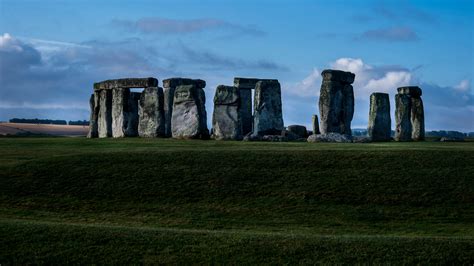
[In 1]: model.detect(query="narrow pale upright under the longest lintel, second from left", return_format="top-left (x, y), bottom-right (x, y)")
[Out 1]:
top-left (97, 90), bottom-right (112, 138)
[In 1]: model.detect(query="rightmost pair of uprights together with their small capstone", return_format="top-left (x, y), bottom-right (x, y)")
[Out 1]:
top-left (395, 86), bottom-right (425, 141)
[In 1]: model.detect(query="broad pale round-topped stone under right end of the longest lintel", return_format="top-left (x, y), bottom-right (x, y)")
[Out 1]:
top-left (138, 87), bottom-right (165, 138)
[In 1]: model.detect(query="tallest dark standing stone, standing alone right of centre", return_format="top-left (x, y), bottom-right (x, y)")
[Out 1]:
top-left (319, 69), bottom-right (355, 136)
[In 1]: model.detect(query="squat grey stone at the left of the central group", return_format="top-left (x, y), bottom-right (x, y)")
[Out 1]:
top-left (212, 85), bottom-right (243, 140)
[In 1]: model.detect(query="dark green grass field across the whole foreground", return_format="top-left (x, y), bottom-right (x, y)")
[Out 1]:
top-left (0, 138), bottom-right (474, 265)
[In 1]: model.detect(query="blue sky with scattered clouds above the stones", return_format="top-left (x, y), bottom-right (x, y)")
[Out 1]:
top-left (0, 0), bottom-right (474, 132)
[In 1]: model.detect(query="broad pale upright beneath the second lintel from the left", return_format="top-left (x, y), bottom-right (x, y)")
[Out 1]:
top-left (171, 85), bottom-right (209, 139)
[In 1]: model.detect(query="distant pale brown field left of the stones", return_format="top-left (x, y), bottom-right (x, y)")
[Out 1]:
top-left (0, 123), bottom-right (89, 136)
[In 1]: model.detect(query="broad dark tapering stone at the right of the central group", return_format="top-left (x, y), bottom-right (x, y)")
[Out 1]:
top-left (252, 80), bottom-right (283, 136)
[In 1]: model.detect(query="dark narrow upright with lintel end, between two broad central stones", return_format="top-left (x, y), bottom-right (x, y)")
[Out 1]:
top-left (234, 77), bottom-right (259, 136)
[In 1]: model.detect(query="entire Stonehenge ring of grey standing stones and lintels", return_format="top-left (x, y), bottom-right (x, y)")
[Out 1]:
top-left (87, 72), bottom-right (425, 142)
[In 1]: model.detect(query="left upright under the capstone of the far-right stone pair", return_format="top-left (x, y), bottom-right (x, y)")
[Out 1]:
top-left (395, 94), bottom-right (412, 141)
